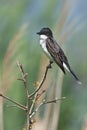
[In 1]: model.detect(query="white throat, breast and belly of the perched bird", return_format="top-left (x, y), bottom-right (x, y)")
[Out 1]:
top-left (40, 35), bottom-right (52, 59)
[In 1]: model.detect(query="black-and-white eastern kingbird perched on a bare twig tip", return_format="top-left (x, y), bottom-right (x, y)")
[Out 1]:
top-left (37, 28), bottom-right (81, 84)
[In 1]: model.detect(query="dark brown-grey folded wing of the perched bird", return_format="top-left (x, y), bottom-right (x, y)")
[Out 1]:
top-left (46, 38), bottom-right (68, 73)
